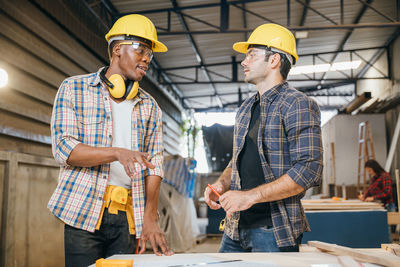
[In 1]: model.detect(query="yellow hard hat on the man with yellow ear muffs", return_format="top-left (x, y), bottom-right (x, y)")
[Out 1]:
top-left (106, 14), bottom-right (168, 52)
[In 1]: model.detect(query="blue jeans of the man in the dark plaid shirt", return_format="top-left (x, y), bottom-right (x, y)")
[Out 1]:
top-left (219, 227), bottom-right (303, 253)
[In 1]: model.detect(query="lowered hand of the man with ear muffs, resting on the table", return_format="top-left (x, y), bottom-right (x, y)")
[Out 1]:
top-left (139, 215), bottom-right (174, 256)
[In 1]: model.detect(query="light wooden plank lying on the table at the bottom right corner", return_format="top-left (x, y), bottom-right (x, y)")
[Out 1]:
top-left (307, 241), bottom-right (400, 267)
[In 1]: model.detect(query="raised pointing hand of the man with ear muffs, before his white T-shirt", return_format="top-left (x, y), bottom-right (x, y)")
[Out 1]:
top-left (116, 148), bottom-right (155, 179)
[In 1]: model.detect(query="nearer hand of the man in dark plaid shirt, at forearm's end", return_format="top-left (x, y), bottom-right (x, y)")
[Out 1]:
top-left (219, 190), bottom-right (256, 218)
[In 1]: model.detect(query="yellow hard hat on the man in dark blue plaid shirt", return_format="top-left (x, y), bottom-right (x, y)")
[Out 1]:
top-left (233, 23), bottom-right (299, 61)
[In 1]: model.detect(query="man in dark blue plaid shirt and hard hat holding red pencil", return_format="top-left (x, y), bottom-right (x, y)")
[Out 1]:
top-left (204, 24), bottom-right (322, 252)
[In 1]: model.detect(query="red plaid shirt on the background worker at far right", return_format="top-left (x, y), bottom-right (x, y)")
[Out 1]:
top-left (364, 172), bottom-right (393, 204)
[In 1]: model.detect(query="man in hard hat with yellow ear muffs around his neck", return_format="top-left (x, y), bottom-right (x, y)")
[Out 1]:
top-left (48, 14), bottom-right (173, 267)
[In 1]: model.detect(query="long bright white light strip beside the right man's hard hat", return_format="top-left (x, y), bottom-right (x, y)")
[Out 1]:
top-left (289, 60), bottom-right (361, 75)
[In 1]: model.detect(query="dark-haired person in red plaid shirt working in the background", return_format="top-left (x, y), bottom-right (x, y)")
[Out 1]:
top-left (358, 159), bottom-right (396, 211)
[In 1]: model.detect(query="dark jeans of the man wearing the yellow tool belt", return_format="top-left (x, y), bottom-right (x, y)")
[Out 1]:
top-left (64, 209), bottom-right (136, 267)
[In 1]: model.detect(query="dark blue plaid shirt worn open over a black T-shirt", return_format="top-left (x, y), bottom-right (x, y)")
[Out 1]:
top-left (225, 82), bottom-right (322, 247)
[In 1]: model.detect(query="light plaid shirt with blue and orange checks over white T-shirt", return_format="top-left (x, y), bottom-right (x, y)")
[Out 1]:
top-left (48, 69), bottom-right (163, 238)
